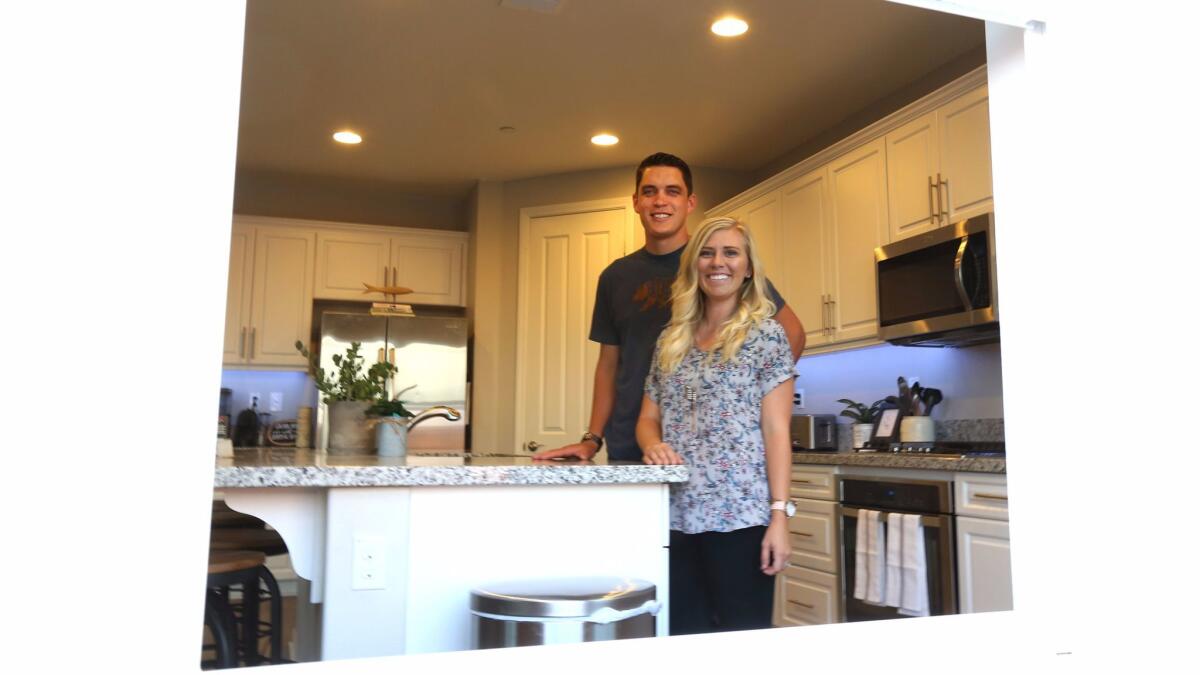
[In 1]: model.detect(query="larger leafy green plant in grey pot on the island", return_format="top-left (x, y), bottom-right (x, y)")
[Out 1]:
top-left (295, 340), bottom-right (396, 455)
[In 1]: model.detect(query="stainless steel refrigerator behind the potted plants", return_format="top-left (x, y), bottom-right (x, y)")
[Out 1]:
top-left (316, 309), bottom-right (470, 452)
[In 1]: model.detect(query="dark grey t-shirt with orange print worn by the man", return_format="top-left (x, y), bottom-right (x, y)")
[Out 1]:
top-left (588, 241), bottom-right (785, 461)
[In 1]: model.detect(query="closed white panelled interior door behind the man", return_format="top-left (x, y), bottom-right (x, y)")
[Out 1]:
top-left (516, 199), bottom-right (631, 452)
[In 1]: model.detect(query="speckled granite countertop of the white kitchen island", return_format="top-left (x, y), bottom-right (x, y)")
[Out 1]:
top-left (212, 448), bottom-right (688, 489)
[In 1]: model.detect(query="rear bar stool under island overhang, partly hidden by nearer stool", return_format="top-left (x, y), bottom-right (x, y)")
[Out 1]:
top-left (209, 527), bottom-right (288, 664)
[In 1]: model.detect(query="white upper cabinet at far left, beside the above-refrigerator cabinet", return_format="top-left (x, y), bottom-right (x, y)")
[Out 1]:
top-left (223, 220), bottom-right (316, 368)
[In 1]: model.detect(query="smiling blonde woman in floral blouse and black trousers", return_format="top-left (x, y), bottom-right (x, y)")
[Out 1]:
top-left (637, 217), bottom-right (794, 635)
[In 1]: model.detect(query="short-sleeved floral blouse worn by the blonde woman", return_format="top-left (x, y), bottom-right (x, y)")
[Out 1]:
top-left (646, 318), bottom-right (794, 534)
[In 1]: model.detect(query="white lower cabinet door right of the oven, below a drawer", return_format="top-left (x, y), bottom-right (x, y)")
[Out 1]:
top-left (955, 515), bottom-right (1013, 614)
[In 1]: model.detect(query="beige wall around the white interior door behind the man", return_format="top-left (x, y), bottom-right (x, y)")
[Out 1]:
top-left (468, 159), bottom-right (754, 452)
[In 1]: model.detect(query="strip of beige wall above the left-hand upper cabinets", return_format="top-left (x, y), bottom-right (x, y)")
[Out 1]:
top-left (233, 169), bottom-right (467, 232)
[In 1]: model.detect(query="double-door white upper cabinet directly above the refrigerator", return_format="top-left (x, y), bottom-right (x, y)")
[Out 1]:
top-left (313, 226), bottom-right (467, 306)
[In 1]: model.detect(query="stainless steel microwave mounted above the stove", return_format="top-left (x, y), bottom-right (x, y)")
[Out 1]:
top-left (875, 213), bottom-right (1000, 347)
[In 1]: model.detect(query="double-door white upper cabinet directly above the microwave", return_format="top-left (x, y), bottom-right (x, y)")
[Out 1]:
top-left (886, 85), bottom-right (991, 241)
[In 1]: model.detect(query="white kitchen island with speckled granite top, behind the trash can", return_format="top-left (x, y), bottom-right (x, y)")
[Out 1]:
top-left (214, 449), bottom-right (688, 661)
